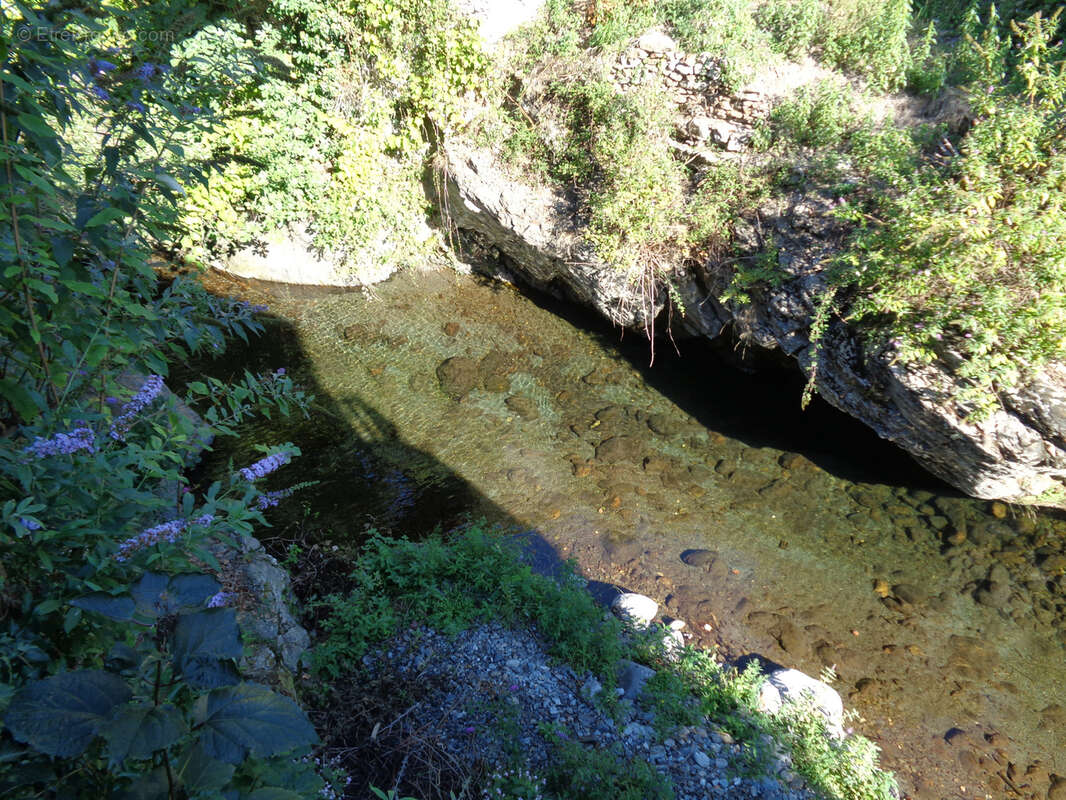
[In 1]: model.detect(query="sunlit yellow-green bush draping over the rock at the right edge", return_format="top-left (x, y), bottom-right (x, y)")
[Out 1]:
top-left (834, 7), bottom-right (1066, 415)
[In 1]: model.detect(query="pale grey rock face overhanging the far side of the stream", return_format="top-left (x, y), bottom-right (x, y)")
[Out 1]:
top-left (442, 120), bottom-right (1066, 506)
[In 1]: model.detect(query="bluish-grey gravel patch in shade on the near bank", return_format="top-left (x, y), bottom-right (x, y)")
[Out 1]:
top-left (365, 624), bottom-right (814, 800)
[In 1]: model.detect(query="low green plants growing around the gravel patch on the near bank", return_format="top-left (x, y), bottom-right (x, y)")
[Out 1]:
top-left (313, 526), bottom-right (892, 800)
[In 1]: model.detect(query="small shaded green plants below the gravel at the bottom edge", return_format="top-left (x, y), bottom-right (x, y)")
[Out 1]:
top-left (544, 725), bottom-right (674, 800)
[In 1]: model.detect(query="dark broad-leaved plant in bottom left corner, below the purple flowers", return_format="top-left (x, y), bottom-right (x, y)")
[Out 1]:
top-left (4, 573), bottom-right (323, 798)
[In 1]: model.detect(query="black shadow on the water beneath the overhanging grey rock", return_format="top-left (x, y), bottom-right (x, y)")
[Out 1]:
top-left (503, 286), bottom-right (963, 497)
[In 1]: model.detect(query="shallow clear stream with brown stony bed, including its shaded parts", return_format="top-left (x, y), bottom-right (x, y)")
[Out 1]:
top-left (189, 264), bottom-right (1066, 798)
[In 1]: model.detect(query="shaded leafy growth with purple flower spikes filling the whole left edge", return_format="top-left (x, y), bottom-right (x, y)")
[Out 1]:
top-left (0, 4), bottom-right (318, 798)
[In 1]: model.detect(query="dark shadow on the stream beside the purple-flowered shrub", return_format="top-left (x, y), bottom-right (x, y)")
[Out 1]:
top-left (173, 305), bottom-right (588, 584)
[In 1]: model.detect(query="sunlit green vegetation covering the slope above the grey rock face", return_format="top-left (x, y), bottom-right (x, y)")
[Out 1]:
top-left (480, 0), bottom-right (1066, 417)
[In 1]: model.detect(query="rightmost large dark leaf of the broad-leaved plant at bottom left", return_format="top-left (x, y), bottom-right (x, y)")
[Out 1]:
top-left (195, 684), bottom-right (318, 764)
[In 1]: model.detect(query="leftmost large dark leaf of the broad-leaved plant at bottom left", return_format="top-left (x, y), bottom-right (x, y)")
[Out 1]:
top-left (3, 670), bottom-right (132, 757)
